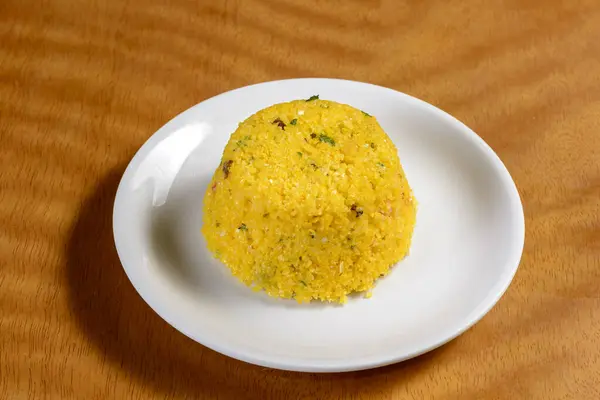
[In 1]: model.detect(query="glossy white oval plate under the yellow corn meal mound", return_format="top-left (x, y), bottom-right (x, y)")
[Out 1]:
top-left (113, 79), bottom-right (525, 372)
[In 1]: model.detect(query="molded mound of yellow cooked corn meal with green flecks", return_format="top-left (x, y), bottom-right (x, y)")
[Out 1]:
top-left (202, 96), bottom-right (416, 303)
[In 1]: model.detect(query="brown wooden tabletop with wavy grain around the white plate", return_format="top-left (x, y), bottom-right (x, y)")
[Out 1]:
top-left (0, 0), bottom-right (600, 399)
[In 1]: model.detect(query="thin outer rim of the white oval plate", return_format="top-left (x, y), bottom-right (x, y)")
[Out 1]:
top-left (111, 78), bottom-right (525, 373)
